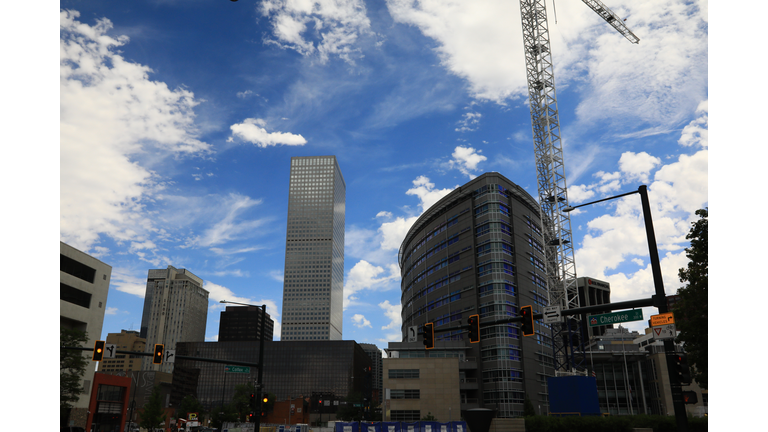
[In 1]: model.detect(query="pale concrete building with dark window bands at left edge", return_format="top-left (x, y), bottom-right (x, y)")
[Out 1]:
top-left (59, 242), bottom-right (112, 427)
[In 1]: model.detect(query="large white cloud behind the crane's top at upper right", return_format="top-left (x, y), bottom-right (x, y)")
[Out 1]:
top-left (387, 0), bottom-right (708, 132)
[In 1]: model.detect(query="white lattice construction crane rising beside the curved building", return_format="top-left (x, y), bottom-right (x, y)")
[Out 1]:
top-left (520, 0), bottom-right (640, 374)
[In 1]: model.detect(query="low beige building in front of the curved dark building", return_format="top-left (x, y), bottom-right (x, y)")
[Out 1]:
top-left (382, 357), bottom-right (462, 422)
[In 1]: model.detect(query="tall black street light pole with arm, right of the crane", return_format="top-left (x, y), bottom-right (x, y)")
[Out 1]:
top-left (563, 185), bottom-right (688, 432)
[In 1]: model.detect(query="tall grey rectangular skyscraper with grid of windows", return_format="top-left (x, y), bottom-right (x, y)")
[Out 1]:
top-left (281, 156), bottom-right (347, 340)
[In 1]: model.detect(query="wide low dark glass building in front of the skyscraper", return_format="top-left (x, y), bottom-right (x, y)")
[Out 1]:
top-left (171, 341), bottom-right (371, 409)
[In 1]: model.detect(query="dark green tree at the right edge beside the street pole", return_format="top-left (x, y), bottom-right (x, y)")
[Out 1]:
top-left (673, 208), bottom-right (709, 388)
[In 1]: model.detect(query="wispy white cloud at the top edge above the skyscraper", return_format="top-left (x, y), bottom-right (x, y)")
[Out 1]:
top-left (259, 0), bottom-right (371, 64)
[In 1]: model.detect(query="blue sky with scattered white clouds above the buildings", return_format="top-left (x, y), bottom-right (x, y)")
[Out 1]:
top-left (59, 0), bottom-right (709, 348)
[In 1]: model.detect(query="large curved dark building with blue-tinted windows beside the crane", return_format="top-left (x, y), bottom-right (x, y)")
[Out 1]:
top-left (400, 173), bottom-right (554, 418)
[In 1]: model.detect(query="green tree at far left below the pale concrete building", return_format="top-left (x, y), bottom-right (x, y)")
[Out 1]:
top-left (59, 328), bottom-right (91, 426)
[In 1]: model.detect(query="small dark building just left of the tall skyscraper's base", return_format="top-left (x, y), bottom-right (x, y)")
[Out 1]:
top-left (219, 306), bottom-right (275, 342)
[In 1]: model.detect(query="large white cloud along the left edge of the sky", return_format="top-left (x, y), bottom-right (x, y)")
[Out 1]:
top-left (59, 10), bottom-right (210, 252)
